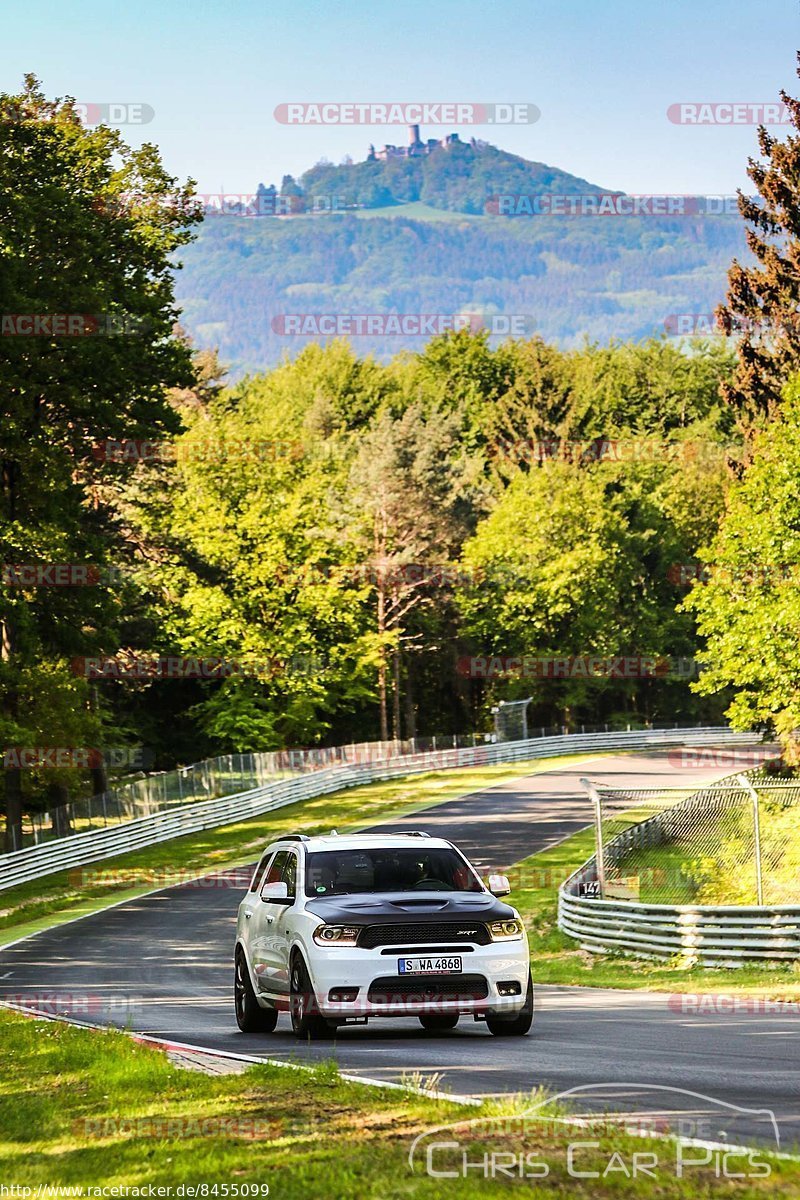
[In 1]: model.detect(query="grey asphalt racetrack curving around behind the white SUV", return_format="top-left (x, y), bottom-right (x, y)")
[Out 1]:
top-left (0, 750), bottom-right (800, 1150)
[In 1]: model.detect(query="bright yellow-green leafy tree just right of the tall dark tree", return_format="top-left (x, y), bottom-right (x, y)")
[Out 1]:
top-left (137, 343), bottom-right (393, 751)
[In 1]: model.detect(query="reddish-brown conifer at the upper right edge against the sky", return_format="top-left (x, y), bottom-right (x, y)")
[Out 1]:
top-left (716, 54), bottom-right (800, 430)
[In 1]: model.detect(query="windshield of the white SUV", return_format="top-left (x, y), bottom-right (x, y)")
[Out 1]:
top-left (306, 846), bottom-right (483, 896)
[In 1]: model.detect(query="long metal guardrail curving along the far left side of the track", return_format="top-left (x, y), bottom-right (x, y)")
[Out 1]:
top-left (0, 727), bottom-right (758, 890)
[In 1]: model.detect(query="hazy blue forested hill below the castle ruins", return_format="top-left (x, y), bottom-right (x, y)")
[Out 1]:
top-left (176, 131), bottom-right (746, 376)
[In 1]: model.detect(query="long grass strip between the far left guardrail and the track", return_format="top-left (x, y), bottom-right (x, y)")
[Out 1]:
top-left (0, 754), bottom-right (588, 944)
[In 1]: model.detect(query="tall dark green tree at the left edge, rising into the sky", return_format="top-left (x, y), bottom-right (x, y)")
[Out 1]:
top-left (0, 77), bottom-right (198, 840)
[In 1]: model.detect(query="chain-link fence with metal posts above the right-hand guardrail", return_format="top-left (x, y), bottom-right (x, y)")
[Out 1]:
top-left (583, 768), bottom-right (800, 905)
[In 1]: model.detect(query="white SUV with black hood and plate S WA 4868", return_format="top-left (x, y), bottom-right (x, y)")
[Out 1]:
top-left (235, 833), bottom-right (534, 1038)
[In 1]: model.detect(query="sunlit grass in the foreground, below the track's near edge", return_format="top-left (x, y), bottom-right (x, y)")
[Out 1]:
top-left (0, 1009), bottom-right (800, 1200)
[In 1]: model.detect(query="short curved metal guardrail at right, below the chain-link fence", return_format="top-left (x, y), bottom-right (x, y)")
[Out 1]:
top-left (558, 780), bottom-right (800, 966)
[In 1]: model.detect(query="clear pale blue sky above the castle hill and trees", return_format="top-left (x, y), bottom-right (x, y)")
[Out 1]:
top-left (0, 0), bottom-right (800, 193)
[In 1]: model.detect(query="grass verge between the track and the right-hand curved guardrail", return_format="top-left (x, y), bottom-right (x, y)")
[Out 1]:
top-left (510, 829), bottom-right (800, 1001)
